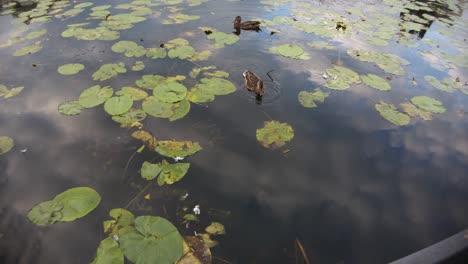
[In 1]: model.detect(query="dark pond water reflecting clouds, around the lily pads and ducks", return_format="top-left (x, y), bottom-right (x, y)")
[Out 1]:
top-left (0, 0), bottom-right (468, 264)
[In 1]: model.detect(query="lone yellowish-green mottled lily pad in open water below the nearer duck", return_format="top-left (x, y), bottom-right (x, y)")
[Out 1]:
top-left (256, 121), bottom-right (294, 149)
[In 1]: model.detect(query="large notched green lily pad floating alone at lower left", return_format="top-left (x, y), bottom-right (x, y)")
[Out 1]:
top-left (28, 187), bottom-right (101, 226)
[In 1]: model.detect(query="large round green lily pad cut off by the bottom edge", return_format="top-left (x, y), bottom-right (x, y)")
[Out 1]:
top-left (119, 216), bottom-right (183, 264)
